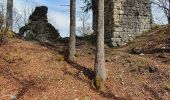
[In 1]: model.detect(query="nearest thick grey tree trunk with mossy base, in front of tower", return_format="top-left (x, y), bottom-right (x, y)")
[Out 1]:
top-left (94, 0), bottom-right (107, 89)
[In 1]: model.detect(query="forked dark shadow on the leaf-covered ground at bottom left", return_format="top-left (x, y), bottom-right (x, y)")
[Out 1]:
top-left (0, 66), bottom-right (43, 100)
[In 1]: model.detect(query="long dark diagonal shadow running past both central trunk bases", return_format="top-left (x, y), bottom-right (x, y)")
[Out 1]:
top-left (39, 43), bottom-right (127, 100)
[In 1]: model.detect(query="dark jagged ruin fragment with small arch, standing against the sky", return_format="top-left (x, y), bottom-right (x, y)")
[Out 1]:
top-left (19, 6), bottom-right (60, 42)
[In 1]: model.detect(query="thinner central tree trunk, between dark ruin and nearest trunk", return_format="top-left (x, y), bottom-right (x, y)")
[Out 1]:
top-left (68, 0), bottom-right (76, 60)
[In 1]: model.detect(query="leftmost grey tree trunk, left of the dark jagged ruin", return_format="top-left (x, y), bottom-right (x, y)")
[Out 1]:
top-left (6, 0), bottom-right (13, 31)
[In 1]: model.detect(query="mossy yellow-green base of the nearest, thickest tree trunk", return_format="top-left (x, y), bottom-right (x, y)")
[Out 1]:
top-left (93, 77), bottom-right (104, 90)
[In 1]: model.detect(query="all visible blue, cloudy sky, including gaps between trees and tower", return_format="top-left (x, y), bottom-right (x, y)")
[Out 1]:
top-left (0, 0), bottom-right (167, 37)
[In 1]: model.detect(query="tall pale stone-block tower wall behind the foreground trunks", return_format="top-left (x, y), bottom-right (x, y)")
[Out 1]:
top-left (93, 0), bottom-right (151, 47)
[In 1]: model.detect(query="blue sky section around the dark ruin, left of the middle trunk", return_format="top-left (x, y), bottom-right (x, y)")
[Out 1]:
top-left (14, 0), bottom-right (76, 36)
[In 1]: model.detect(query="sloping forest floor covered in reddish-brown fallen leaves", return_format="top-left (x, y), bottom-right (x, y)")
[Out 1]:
top-left (0, 28), bottom-right (170, 100)
